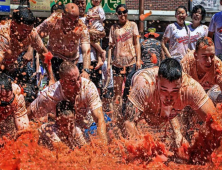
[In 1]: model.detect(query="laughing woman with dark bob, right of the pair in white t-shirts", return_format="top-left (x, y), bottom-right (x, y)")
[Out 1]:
top-left (188, 5), bottom-right (208, 50)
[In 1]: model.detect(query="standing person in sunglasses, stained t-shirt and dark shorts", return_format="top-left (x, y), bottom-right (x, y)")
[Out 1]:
top-left (107, 4), bottom-right (141, 116)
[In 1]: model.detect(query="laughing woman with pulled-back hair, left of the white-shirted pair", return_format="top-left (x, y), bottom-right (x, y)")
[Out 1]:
top-left (162, 6), bottom-right (189, 61)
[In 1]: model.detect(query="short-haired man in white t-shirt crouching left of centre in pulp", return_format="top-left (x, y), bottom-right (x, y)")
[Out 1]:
top-left (28, 61), bottom-right (107, 143)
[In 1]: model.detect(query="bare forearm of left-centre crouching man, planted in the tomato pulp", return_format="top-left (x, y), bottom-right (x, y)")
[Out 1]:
top-left (92, 107), bottom-right (107, 144)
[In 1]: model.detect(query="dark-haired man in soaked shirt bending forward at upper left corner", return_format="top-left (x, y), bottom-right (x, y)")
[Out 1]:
top-left (0, 7), bottom-right (54, 83)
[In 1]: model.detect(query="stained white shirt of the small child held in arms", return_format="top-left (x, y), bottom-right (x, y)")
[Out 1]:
top-left (87, 6), bottom-right (106, 31)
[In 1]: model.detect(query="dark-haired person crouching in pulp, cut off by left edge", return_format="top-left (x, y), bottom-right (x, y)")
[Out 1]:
top-left (0, 73), bottom-right (29, 137)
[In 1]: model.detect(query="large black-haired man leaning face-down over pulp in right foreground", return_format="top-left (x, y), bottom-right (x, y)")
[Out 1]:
top-left (124, 58), bottom-right (221, 154)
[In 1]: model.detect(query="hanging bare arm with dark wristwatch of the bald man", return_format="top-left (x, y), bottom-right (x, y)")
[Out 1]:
top-left (81, 43), bottom-right (91, 79)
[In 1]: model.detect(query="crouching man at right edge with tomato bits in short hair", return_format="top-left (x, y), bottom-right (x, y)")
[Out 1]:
top-left (181, 37), bottom-right (222, 104)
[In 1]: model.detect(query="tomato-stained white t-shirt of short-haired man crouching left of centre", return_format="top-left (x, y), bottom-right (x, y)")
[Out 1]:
top-left (31, 78), bottom-right (102, 128)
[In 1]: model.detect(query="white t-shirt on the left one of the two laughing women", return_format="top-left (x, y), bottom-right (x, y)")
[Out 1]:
top-left (163, 22), bottom-right (189, 61)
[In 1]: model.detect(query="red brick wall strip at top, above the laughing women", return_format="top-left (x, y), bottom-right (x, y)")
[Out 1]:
top-left (126, 0), bottom-right (189, 11)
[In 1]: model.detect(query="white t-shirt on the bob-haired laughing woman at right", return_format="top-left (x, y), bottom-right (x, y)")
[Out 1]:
top-left (188, 24), bottom-right (208, 50)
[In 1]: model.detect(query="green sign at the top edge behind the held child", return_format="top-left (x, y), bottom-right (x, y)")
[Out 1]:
top-left (86, 0), bottom-right (126, 13)
